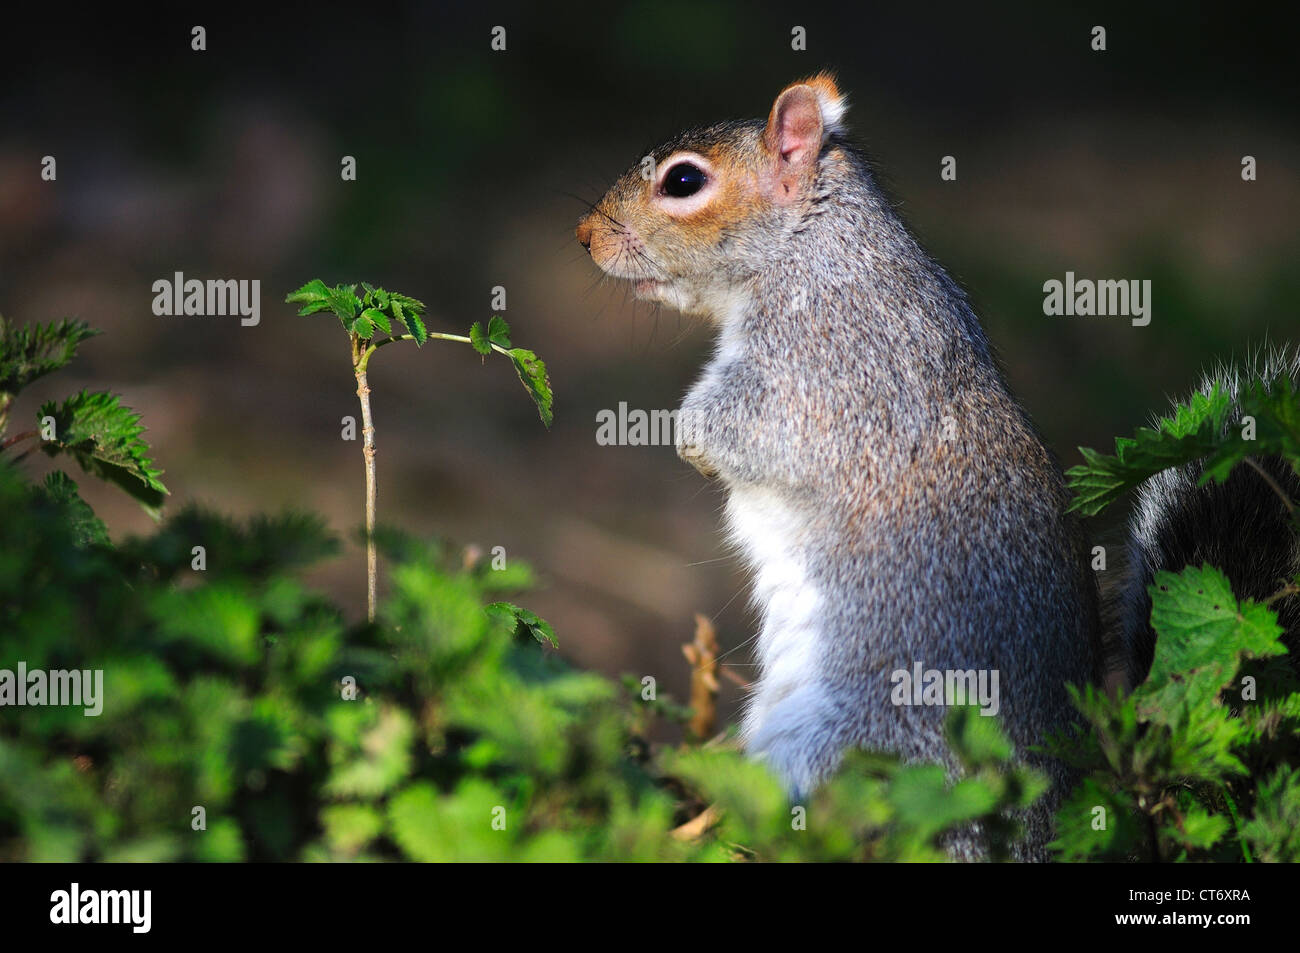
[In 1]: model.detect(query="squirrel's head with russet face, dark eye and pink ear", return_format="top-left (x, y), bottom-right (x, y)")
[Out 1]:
top-left (577, 73), bottom-right (846, 316)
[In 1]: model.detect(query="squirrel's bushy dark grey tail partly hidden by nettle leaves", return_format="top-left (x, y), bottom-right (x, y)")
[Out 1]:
top-left (1104, 348), bottom-right (1300, 688)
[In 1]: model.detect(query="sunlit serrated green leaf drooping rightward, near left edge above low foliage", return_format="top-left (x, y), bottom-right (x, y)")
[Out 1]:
top-left (36, 390), bottom-right (168, 517)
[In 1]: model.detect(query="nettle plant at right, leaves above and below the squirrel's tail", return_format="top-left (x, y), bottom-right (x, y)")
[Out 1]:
top-left (1052, 377), bottom-right (1300, 862)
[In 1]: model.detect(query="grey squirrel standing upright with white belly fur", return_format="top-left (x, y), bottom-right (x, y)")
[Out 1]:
top-left (577, 73), bottom-right (1295, 859)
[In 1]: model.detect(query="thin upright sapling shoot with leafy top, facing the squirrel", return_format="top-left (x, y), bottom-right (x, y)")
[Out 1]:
top-left (285, 278), bottom-right (551, 621)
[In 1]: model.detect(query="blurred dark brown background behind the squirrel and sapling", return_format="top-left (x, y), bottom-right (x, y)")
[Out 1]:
top-left (0, 0), bottom-right (1300, 722)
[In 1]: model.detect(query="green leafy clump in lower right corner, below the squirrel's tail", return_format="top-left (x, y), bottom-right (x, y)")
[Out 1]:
top-left (1054, 567), bottom-right (1300, 861)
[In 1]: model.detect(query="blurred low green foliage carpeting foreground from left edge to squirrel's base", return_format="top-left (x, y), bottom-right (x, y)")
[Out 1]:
top-left (0, 452), bottom-right (1041, 861)
